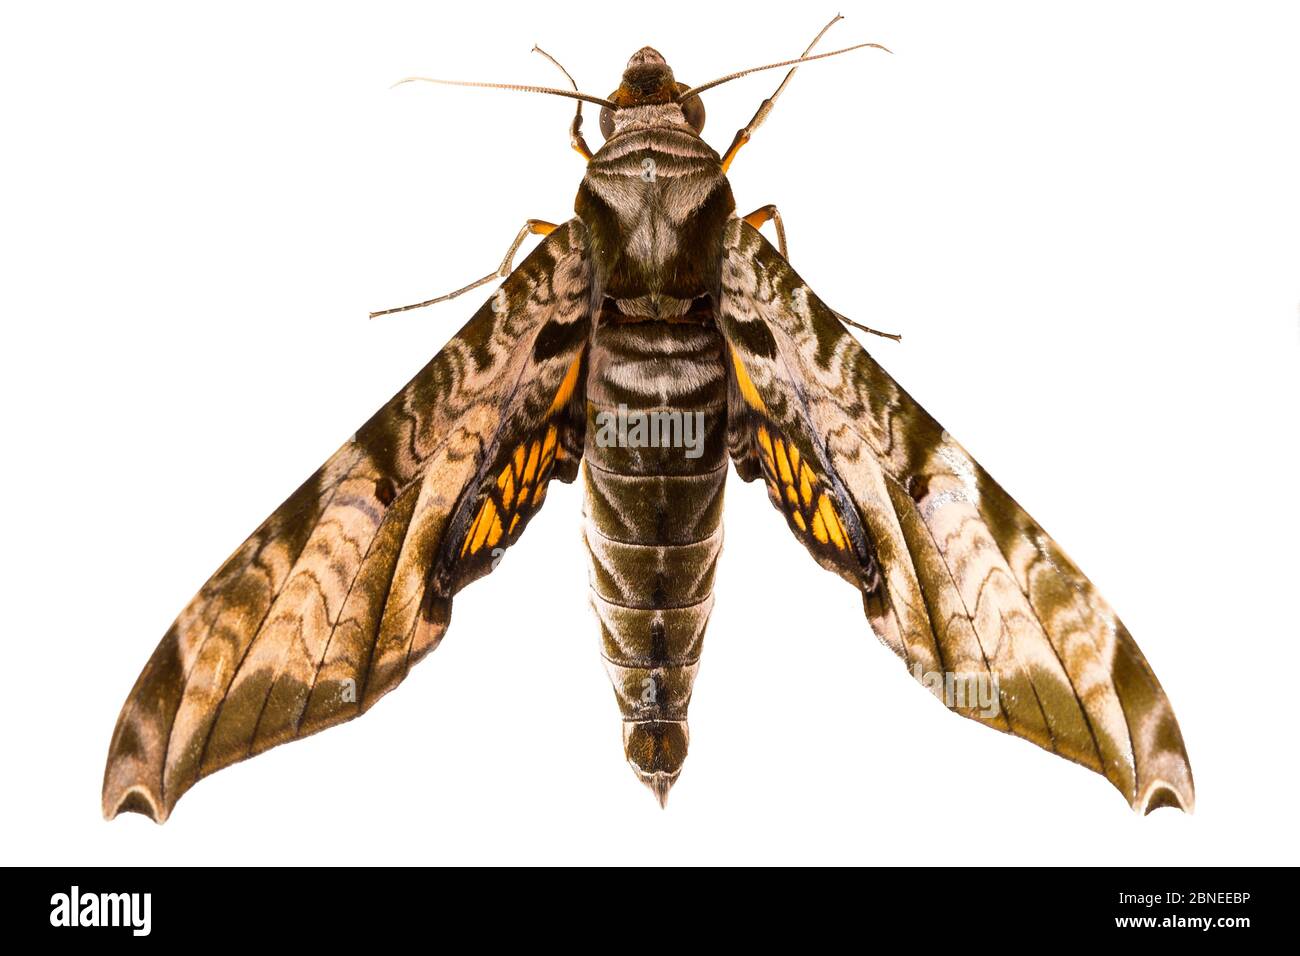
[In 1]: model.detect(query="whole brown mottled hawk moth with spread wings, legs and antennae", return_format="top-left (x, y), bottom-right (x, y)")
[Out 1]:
top-left (103, 18), bottom-right (1195, 822)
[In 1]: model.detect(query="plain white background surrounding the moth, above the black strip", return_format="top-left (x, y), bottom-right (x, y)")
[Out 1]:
top-left (0, 0), bottom-right (1300, 866)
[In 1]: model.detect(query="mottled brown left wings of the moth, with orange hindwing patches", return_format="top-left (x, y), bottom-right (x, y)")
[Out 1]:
top-left (103, 220), bottom-right (590, 822)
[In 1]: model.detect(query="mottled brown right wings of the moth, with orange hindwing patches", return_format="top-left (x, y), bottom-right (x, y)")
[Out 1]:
top-left (719, 220), bottom-right (1195, 812)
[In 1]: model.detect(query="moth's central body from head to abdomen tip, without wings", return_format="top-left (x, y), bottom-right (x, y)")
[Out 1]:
top-left (575, 47), bottom-right (736, 803)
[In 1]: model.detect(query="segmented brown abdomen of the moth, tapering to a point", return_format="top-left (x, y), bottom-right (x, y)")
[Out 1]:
top-left (584, 320), bottom-right (727, 803)
